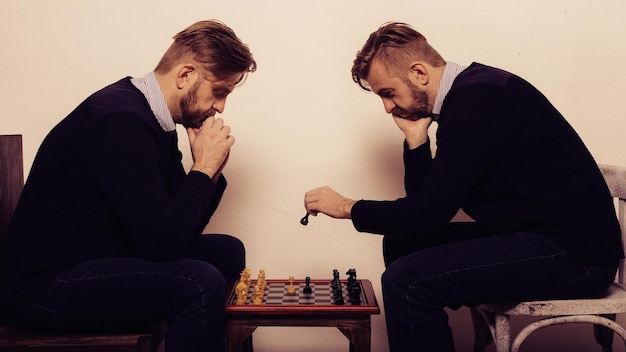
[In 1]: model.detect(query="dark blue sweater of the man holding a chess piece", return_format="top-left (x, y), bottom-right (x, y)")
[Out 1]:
top-left (352, 63), bottom-right (623, 263)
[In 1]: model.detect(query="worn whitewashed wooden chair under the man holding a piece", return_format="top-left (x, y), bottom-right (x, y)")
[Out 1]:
top-left (471, 165), bottom-right (626, 352)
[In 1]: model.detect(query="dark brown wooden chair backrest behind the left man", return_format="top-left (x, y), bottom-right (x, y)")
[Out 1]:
top-left (0, 135), bottom-right (24, 325)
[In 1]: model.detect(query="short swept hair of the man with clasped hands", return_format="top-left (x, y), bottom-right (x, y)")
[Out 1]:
top-left (155, 20), bottom-right (257, 81)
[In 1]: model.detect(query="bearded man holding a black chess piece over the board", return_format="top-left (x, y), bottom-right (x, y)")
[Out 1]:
top-left (304, 23), bottom-right (622, 352)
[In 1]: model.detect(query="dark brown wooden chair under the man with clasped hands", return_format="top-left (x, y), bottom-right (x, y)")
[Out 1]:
top-left (0, 135), bottom-right (152, 352)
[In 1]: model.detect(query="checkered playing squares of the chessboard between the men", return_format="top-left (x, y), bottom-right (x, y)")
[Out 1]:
top-left (230, 282), bottom-right (365, 306)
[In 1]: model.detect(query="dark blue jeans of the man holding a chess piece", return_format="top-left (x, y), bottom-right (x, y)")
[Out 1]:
top-left (382, 223), bottom-right (617, 352)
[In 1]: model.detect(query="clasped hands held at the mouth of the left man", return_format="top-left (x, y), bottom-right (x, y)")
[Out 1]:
top-left (187, 116), bottom-right (235, 182)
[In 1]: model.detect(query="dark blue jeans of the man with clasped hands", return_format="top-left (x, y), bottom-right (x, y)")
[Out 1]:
top-left (12, 235), bottom-right (245, 352)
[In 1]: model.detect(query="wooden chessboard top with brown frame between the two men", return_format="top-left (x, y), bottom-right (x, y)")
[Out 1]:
top-left (226, 280), bottom-right (380, 314)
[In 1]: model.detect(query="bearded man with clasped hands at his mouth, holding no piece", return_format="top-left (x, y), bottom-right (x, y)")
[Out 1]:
top-left (3, 21), bottom-right (256, 351)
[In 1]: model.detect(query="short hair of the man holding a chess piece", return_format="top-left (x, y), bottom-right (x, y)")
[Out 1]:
top-left (352, 22), bottom-right (446, 91)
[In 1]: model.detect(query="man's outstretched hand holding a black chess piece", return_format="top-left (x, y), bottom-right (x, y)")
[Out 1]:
top-left (304, 186), bottom-right (356, 219)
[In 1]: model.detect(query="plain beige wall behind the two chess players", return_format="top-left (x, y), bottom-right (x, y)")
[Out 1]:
top-left (0, 0), bottom-right (626, 352)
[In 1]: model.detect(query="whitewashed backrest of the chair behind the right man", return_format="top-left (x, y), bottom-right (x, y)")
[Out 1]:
top-left (599, 164), bottom-right (626, 285)
